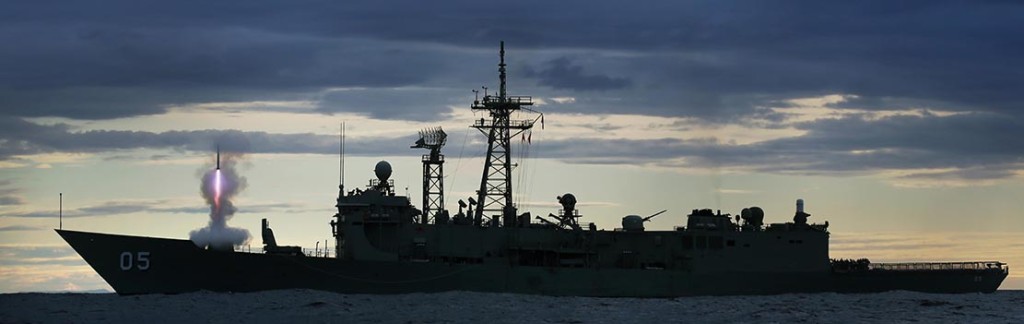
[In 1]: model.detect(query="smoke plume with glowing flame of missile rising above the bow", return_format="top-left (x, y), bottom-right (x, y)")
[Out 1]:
top-left (188, 153), bottom-right (250, 250)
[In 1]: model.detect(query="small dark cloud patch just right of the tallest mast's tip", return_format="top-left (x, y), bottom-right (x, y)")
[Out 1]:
top-left (523, 56), bottom-right (632, 91)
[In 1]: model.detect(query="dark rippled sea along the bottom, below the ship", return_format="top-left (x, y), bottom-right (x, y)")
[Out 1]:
top-left (0, 290), bottom-right (1024, 324)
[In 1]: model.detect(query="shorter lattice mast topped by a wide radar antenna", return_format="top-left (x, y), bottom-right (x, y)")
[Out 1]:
top-left (411, 126), bottom-right (447, 224)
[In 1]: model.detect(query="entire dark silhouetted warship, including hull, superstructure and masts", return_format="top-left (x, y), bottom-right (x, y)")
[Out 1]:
top-left (56, 43), bottom-right (1009, 297)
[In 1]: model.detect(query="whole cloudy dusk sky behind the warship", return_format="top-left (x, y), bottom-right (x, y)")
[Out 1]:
top-left (0, 0), bottom-right (1024, 292)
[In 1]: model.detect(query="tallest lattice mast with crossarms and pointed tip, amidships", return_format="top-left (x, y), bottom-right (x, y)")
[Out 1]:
top-left (472, 41), bottom-right (536, 226)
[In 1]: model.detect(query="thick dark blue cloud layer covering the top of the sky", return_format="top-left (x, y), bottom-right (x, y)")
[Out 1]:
top-left (0, 1), bottom-right (1024, 119)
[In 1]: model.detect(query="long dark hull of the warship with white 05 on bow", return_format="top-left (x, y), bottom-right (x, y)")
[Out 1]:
top-left (57, 230), bottom-right (1007, 297)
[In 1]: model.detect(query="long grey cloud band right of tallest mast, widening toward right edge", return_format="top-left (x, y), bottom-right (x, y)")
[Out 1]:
top-left (543, 113), bottom-right (1024, 180)
